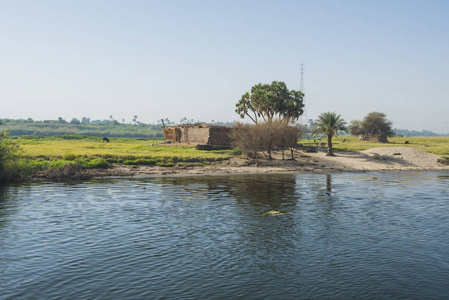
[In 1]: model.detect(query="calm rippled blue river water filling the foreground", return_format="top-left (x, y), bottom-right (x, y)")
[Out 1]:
top-left (0, 172), bottom-right (449, 299)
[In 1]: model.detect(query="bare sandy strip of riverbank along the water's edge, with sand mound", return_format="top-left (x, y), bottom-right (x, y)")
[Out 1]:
top-left (35, 147), bottom-right (449, 180)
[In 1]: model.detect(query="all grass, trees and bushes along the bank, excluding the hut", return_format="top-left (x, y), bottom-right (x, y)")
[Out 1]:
top-left (0, 92), bottom-right (449, 182)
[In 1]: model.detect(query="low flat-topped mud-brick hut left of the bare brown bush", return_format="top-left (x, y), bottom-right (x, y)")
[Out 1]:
top-left (163, 124), bottom-right (232, 147)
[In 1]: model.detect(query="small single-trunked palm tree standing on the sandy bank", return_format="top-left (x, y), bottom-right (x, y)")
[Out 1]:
top-left (312, 112), bottom-right (348, 156)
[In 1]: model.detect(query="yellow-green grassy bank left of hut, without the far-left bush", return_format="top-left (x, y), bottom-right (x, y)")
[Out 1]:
top-left (15, 138), bottom-right (231, 170)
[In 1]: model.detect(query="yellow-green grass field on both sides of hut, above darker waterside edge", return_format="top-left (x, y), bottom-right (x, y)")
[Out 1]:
top-left (20, 136), bottom-right (449, 161)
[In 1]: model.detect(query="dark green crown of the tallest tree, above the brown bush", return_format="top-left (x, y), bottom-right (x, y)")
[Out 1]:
top-left (235, 81), bottom-right (304, 124)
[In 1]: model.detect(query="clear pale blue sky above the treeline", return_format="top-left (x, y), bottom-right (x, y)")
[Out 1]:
top-left (0, 0), bottom-right (449, 133)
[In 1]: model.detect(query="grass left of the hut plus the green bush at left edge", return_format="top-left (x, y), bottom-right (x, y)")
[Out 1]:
top-left (0, 134), bottom-right (231, 181)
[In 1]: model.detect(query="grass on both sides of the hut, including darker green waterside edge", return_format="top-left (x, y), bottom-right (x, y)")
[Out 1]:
top-left (15, 136), bottom-right (449, 168)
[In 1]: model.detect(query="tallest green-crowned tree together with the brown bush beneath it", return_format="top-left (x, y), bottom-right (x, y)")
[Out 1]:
top-left (230, 81), bottom-right (304, 159)
